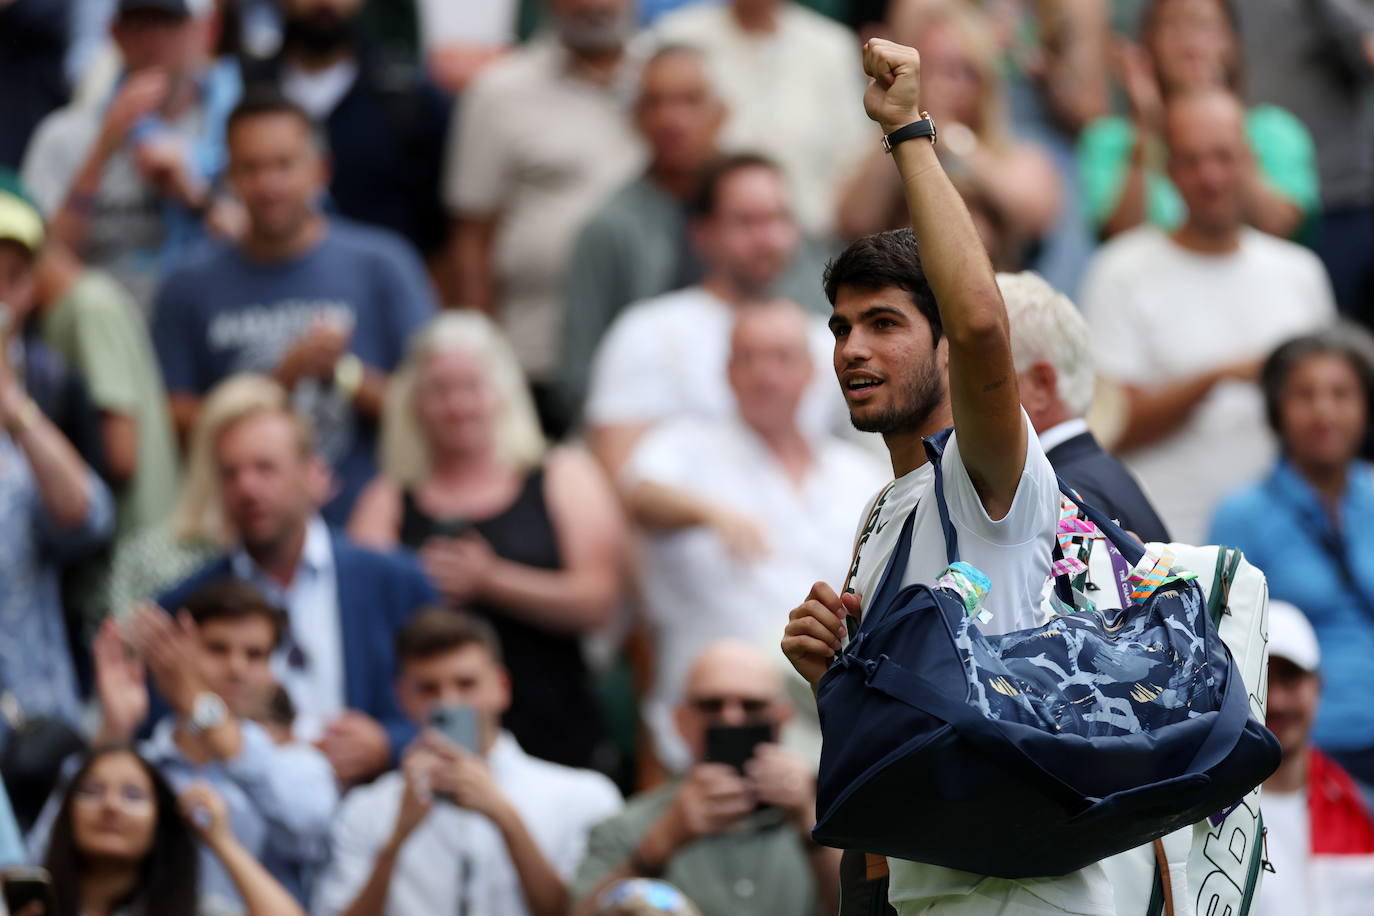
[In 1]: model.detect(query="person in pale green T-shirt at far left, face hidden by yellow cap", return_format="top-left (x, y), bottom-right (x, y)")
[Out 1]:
top-left (38, 244), bottom-right (180, 538)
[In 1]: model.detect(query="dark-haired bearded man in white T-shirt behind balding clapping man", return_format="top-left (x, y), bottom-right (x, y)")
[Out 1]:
top-left (584, 154), bottom-right (844, 475)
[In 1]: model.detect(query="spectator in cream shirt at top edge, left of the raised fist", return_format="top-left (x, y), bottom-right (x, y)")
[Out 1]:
top-left (654, 0), bottom-right (872, 238)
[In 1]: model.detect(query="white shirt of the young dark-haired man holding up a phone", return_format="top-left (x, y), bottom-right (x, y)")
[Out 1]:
top-left (312, 732), bottom-right (624, 916)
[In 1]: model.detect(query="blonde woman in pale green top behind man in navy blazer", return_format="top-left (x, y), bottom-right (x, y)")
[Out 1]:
top-left (110, 374), bottom-right (303, 615)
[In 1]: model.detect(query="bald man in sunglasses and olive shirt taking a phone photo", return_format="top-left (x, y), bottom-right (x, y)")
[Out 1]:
top-left (573, 640), bottom-right (840, 916)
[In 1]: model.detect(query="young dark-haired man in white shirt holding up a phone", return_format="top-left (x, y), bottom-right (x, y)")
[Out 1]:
top-left (315, 608), bottom-right (621, 916)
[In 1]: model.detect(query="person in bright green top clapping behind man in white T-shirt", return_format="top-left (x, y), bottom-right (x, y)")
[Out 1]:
top-left (1079, 0), bottom-right (1319, 238)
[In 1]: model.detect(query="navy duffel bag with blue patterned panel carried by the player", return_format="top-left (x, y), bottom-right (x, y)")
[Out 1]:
top-left (812, 438), bottom-right (1279, 879)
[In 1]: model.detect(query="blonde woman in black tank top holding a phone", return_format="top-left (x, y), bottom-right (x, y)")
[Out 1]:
top-left (348, 312), bottom-right (624, 766)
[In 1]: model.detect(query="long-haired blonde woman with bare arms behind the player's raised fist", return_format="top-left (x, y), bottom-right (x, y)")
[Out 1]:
top-left (838, 0), bottom-right (1062, 271)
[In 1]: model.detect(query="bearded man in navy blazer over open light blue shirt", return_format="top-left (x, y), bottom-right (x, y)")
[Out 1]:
top-left (159, 398), bottom-right (434, 786)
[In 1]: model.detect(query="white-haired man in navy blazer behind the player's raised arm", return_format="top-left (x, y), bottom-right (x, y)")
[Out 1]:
top-left (998, 271), bottom-right (1169, 542)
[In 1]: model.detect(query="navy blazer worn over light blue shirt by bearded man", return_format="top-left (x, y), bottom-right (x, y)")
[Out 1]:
top-left (154, 531), bottom-right (436, 762)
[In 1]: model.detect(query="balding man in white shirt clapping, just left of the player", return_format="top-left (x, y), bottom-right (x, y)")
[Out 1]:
top-left (621, 301), bottom-right (886, 770)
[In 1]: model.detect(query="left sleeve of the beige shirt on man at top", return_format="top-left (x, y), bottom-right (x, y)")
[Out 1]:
top-left (444, 65), bottom-right (516, 216)
